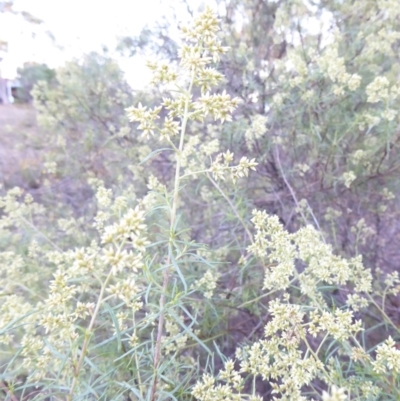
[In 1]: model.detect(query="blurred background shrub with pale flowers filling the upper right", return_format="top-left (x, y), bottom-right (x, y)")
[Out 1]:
top-left (126, 0), bottom-right (400, 271)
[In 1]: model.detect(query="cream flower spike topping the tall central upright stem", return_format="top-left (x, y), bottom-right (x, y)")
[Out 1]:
top-left (126, 8), bottom-right (262, 192)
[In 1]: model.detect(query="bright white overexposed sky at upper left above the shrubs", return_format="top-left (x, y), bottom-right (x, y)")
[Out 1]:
top-left (0, 0), bottom-right (205, 87)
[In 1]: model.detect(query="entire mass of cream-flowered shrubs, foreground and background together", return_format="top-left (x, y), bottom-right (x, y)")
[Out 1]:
top-left (0, 0), bottom-right (400, 401)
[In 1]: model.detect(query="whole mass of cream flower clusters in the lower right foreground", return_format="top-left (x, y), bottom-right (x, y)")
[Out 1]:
top-left (193, 210), bottom-right (386, 401)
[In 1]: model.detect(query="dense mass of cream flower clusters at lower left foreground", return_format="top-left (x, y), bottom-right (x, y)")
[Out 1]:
top-left (0, 180), bottom-right (152, 385)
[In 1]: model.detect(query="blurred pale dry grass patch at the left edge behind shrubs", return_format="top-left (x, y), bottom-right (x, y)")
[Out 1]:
top-left (0, 105), bottom-right (92, 215)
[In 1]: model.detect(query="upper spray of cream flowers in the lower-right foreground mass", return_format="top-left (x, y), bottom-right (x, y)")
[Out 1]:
top-left (248, 210), bottom-right (372, 298)
